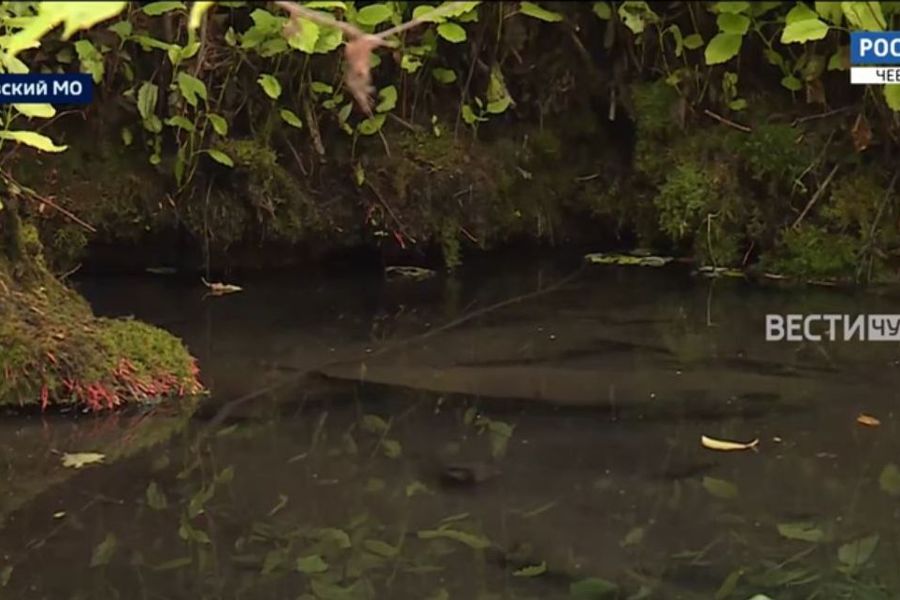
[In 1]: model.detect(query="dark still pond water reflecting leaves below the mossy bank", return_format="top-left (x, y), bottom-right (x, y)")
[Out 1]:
top-left (0, 262), bottom-right (900, 600)
